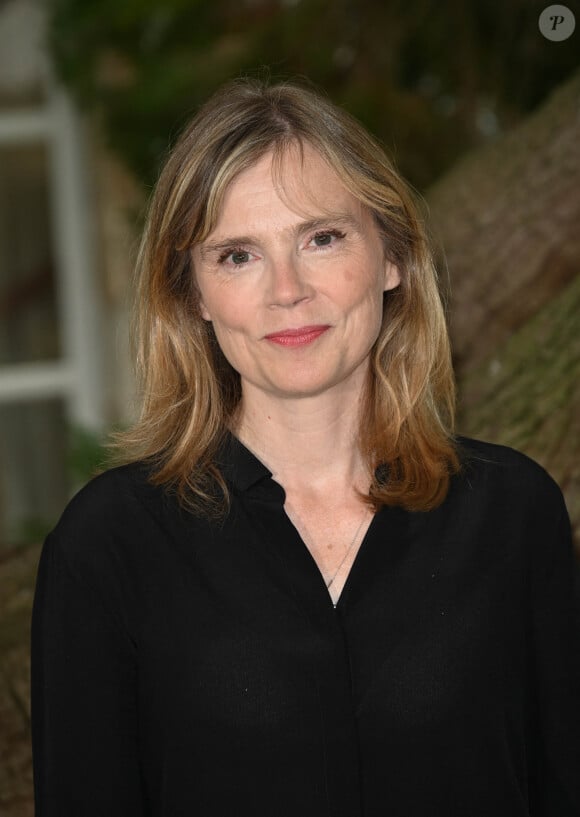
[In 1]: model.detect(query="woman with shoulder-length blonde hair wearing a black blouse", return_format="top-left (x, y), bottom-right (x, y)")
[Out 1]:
top-left (32, 81), bottom-right (580, 817)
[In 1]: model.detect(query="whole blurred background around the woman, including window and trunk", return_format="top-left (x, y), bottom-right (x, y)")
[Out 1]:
top-left (0, 0), bottom-right (580, 817)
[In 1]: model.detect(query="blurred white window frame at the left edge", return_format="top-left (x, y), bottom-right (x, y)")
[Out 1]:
top-left (0, 83), bottom-right (105, 432)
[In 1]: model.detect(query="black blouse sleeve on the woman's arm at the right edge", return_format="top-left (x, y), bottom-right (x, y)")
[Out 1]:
top-left (530, 494), bottom-right (580, 817)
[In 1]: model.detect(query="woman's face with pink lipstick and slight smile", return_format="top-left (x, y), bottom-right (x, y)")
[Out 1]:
top-left (193, 146), bottom-right (400, 399)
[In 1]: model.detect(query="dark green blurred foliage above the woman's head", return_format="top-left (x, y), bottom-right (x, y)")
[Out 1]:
top-left (51, 0), bottom-right (578, 188)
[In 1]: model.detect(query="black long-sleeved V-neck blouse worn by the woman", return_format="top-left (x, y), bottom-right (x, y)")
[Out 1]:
top-left (32, 438), bottom-right (580, 817)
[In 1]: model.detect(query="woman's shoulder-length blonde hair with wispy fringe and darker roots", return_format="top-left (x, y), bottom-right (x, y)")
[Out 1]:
top-left (116, 79), bottom-right (459, 515)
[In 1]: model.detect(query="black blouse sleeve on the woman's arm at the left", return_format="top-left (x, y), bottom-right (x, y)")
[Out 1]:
top-left (31, 534), bottom-right (145, 817)
